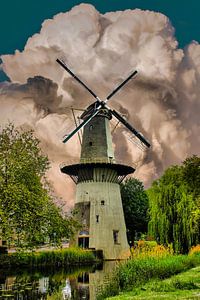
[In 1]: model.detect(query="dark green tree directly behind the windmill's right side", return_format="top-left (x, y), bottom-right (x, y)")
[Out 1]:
top-left (121, 178), bottom-right (148, 241)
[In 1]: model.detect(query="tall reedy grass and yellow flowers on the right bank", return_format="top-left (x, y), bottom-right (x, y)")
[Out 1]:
top-left (97, 244), bottom-right (200, 300)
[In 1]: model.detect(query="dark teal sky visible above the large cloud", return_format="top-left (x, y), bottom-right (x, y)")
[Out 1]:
top-left (0, 0), bottom-right (200, 81)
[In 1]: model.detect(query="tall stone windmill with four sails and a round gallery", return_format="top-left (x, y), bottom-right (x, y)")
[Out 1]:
top-left (57, 59), bottom-right (150, 260)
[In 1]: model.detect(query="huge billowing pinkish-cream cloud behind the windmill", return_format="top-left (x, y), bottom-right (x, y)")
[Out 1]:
top-left (0, 4), bottom-right (200, 206)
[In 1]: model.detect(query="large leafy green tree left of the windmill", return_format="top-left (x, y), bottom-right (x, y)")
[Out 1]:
top-left (0, 124), bottom-right (77, 247)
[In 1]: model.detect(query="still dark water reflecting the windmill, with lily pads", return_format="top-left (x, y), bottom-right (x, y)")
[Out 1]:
top-left (0, 262), bottom-right (115, 300)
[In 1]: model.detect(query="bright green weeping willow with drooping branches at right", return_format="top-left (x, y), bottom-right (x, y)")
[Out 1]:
top-left (147, 165), bottom-right (200, 253)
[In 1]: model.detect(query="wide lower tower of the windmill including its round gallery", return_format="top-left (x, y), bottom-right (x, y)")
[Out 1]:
top-left (61, 161), bottom-right (134, 260)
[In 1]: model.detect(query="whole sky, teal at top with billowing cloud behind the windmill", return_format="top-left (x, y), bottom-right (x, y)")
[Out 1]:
top-left (0, 0), bottom-right (200, 203)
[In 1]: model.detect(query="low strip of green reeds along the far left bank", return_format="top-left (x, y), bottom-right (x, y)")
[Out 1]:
top-left (0, 248), bottom-right (97, 268)
